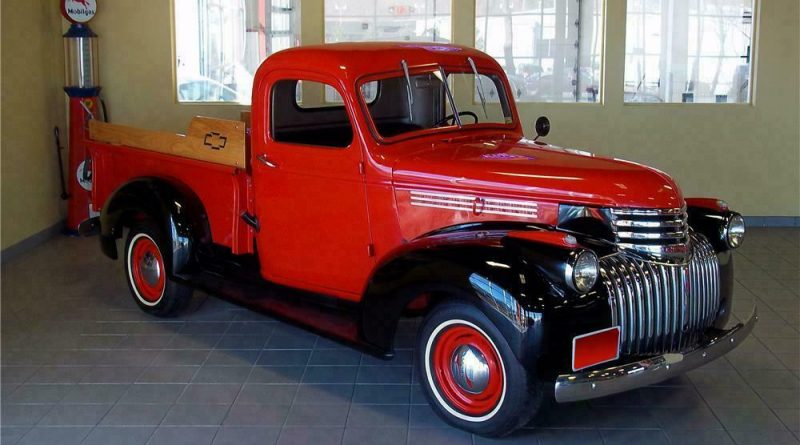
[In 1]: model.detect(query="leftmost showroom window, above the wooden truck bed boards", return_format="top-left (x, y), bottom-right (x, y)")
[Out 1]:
top-left (175, 0), bottom-right (300, 104)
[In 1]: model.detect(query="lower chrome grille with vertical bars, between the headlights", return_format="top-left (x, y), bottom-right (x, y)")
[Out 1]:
top-left (600, 234), bottom-right (720, 354)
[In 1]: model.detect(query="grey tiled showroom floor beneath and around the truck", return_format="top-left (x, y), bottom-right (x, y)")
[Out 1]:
top-left (1, 229), bottom-right (800, 445)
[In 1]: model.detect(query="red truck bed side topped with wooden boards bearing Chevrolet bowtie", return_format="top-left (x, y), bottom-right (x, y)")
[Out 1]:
top-left (87, 117), bottom-right (254, 254)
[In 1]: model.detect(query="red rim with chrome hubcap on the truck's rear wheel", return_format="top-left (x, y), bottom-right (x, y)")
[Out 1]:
top-left (130, 235), bottom-right (166, 303)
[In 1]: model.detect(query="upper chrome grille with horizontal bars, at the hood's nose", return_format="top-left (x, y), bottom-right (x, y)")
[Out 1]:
top-left (610, 208), bottom-right (689, 258)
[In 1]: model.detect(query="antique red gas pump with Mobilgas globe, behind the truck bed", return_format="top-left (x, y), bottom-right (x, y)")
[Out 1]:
top-left (61, 0), bottom-right (100, 232)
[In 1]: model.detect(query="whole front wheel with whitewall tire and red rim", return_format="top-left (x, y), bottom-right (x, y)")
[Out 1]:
top-left (417, 302), bottom-right (541, 437)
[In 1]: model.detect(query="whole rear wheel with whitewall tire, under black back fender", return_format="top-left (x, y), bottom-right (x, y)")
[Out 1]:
top-left (125, 222), bottom-right (192, 317)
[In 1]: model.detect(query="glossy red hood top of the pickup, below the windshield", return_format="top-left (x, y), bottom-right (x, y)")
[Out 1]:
top-left (393, 139), bottom-right (683, 208)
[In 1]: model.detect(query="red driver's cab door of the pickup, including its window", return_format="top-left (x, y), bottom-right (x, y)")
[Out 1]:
top-left (252, 73), bottom-right (374, 300)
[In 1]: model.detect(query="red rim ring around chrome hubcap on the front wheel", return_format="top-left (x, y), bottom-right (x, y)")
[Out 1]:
top-left (430, 324), bottom-right (505, 417)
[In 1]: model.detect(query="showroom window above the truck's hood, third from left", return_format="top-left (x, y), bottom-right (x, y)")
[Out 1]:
top-left (475, 0), bottom-right (603, 102)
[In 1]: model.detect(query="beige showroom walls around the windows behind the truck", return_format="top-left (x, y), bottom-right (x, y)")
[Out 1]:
top-left (2, 0), bottom-right (800, 247)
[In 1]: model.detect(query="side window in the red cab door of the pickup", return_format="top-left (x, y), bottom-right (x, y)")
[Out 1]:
top-left (270, 79), bottom-right (353, 148)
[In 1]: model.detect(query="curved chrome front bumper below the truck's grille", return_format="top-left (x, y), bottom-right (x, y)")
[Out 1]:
top-left (555, 308), bottom-right (758, 402)
